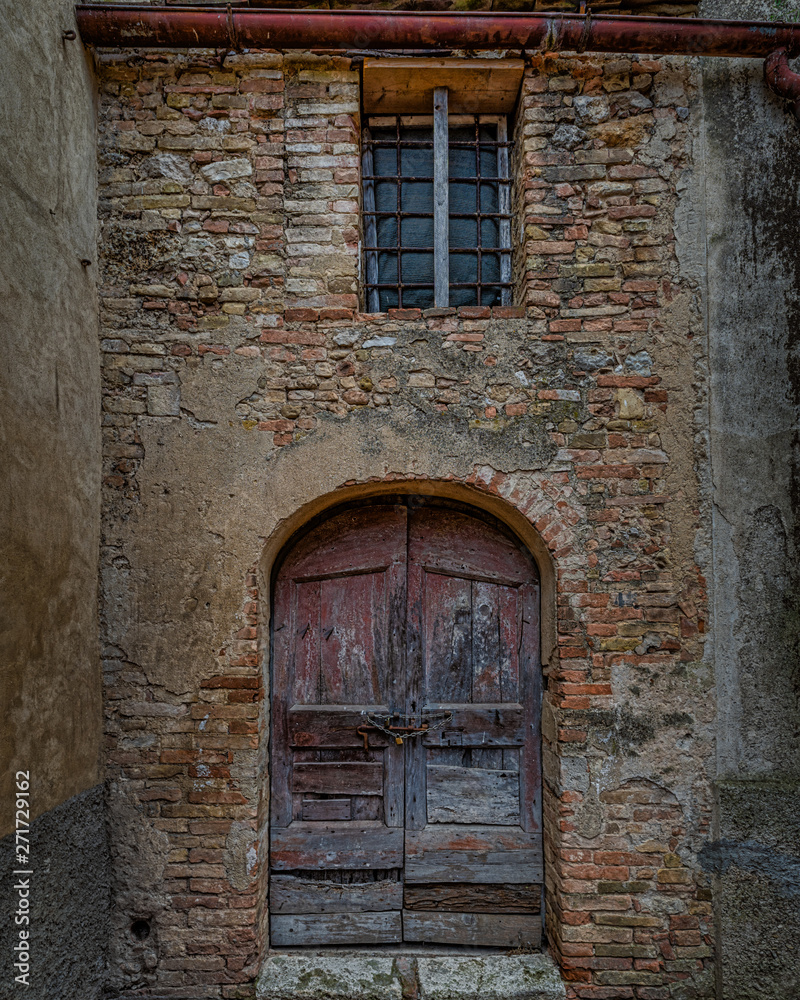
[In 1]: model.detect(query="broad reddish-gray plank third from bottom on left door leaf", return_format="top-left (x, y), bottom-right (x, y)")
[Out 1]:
top-left (270, 821), bottom-right (406, 881)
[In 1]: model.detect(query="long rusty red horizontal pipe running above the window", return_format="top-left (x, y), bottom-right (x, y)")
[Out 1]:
top-left (76, 4), bottom-right (800, 58)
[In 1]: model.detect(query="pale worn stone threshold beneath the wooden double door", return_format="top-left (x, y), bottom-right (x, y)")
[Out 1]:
top-left (256, 951), bottom-right (566, 1000)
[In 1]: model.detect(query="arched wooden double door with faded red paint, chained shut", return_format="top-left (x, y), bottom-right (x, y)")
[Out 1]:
top-left (269, 497), bottom-right (542, 948)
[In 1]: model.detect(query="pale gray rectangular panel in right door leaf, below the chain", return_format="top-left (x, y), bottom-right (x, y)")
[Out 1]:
top-left (428, 764), bottom-right (519, 826)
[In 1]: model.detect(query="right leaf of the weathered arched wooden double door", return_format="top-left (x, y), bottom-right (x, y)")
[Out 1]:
top-left (403, 507), bottom-right (542, 946)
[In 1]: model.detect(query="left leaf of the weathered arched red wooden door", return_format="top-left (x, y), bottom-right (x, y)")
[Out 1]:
top-left (269, 506), bottom-right (407, 946)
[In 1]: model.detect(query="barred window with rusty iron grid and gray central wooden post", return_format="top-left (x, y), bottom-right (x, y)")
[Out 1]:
top-left (362, 104), bottom-right (511, 312)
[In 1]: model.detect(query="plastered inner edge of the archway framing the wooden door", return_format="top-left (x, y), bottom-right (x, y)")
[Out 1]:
top-left (258, 478), bottom-right (557, 963)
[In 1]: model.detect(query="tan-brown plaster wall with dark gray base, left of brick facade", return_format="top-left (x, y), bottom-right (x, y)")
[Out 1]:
top-left (0, 0), bottom-right (108, 1000)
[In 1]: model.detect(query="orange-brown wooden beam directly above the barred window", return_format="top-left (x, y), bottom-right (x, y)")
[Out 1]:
top-left (363, 58), bottom-right (525, 115)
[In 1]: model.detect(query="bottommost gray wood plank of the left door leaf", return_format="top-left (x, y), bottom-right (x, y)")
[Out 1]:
top-left (269, 911), bottom-right (403, 948)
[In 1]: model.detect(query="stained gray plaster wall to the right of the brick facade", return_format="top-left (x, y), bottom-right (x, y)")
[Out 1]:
top-left (702, 3), bottom-right (800, 1000)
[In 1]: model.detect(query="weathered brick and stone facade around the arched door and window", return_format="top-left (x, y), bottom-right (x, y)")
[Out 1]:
top-left (100, 43), bottom-right (713, 1000)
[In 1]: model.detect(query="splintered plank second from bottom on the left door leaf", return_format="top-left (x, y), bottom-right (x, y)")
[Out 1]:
top-left (269, 875), bottom-right (404, 913)
